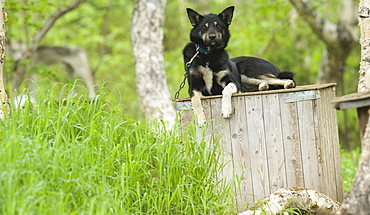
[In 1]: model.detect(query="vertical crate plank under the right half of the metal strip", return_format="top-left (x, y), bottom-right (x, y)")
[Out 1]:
top-left (297, 101), bottom-right (325, 190)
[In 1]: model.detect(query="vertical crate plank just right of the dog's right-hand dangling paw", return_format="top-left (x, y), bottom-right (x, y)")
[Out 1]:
top-left (230, 96), bottom-right (257, 210)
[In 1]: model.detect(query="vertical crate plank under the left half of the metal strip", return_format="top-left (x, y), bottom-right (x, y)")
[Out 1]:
top-left (280, 92), bottom-right (305, 187)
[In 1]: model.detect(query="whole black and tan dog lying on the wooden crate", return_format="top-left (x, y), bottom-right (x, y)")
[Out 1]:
top-left (183, 6), bottom-right (295, 124)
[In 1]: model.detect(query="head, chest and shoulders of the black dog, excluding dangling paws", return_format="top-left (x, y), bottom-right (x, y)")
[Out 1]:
top-left (183, 7), bottom-right (241, 96)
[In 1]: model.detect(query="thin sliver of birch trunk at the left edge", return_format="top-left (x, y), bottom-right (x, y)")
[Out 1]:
top-left (0, 0), bottom-right (10, 119)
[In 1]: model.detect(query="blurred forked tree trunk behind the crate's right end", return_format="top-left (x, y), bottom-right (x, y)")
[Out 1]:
top-left (290, 0), bottom-right (358, 94)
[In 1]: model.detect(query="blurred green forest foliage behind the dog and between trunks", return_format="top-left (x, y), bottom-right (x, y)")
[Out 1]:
top-left (4, 0), bottom-right (361, 150)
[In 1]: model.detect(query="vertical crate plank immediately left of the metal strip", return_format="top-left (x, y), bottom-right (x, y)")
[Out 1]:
top-left (262, 94), bottom-right (287, 192)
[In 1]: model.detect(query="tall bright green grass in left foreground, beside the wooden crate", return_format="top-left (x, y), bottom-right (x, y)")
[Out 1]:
top-left (0, 85), bottom-right (234, 215)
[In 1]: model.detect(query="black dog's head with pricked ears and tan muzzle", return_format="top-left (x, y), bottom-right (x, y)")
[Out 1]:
top-left (187, 6), bottom-right (234, 50)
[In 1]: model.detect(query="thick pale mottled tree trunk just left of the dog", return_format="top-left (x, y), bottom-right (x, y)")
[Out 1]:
top-left (131, 0), bottom-right (176, 126)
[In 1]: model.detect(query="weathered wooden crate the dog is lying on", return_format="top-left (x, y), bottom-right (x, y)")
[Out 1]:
top-left (176, 84), bottom-right (343, 207)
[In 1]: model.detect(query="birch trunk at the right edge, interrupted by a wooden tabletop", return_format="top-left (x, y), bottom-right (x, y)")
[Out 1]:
top-left (336, 0), bottom-right (370, 215)
